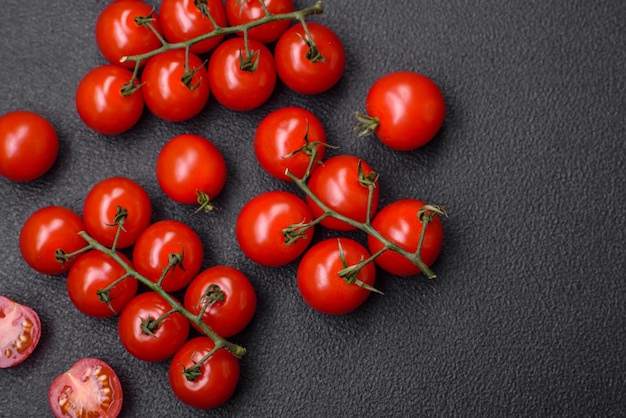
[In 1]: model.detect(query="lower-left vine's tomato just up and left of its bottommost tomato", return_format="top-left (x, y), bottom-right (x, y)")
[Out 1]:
top-left (117, 292), bottom-right (189, 362)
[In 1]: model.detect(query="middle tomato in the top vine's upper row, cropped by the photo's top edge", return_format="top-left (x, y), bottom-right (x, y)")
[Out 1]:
top-left (159, 0), bottom-right (228, 54)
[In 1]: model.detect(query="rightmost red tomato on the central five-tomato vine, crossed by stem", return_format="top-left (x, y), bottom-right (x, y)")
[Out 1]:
top-left (367, 199), bottom-right (443, 276)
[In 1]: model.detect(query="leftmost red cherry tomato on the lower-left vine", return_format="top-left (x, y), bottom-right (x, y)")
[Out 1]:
top-left (19, 206), bottom-right (87, 275)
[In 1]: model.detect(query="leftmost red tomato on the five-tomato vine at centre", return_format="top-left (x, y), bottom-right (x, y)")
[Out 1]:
top-left (235, 190), bottom-right (314, 267)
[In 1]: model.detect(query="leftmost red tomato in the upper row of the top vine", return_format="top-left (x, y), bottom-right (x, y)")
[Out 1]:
top-left (96, 0), bottom-right (161, 68)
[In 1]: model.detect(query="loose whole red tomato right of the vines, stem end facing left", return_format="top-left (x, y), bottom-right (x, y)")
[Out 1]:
top-left (366, 71), bottom-right (446, 151)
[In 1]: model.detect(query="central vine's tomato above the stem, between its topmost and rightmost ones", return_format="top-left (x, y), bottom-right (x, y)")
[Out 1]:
top-left (307, 154), bottom-right (380, 231)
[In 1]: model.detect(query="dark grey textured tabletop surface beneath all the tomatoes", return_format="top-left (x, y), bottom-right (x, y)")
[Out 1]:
top-left (0, 0), bottom-right (626, 417)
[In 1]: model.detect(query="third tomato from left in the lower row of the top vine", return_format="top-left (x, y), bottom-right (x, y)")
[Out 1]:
top-left (209, 38), bottom-right (276, 111)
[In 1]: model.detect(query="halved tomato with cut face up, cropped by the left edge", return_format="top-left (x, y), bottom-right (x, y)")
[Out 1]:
top-left (0, 295), bottom-right (41, 369)
